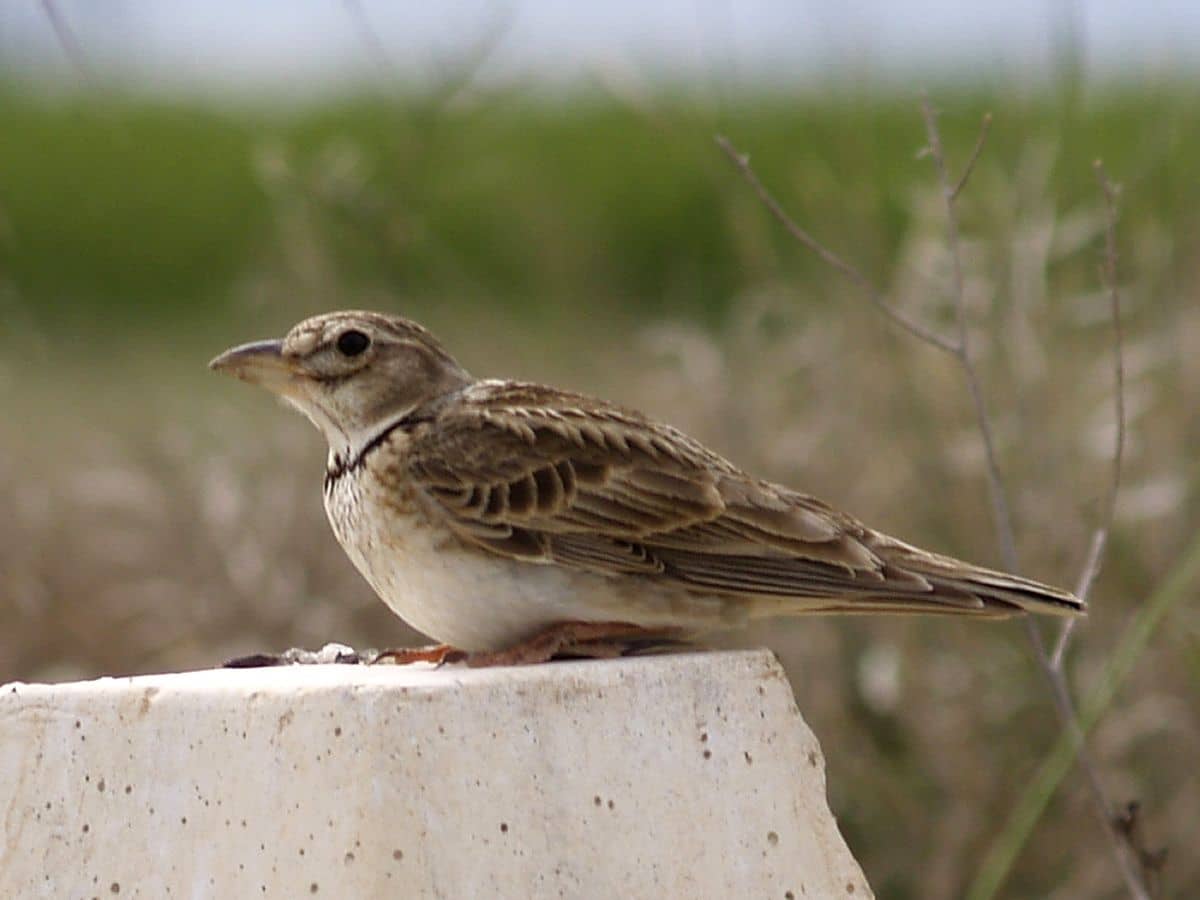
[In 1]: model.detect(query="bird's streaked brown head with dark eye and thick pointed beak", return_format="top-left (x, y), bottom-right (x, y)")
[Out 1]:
top-left (209, 311), bottom-right (472, 451)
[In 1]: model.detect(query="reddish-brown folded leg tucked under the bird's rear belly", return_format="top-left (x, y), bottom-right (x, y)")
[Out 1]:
top-left (463, 622), bottom-right (684, 668)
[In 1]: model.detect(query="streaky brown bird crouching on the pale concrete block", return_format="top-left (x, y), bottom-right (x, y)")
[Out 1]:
top-left (209, 311), bottom-right (1085, 666)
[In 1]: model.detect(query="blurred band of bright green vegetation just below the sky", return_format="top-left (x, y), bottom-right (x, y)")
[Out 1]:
top-left (0, 83), bottom-right (1200, 325)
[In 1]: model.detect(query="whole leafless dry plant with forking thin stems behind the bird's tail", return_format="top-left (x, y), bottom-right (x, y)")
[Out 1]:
top-left (716, 97), bottom-right (1150, 900)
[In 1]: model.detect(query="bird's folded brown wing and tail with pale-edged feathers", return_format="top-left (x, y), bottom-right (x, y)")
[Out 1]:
top-left (406, 383), bottom-right (1080, 614)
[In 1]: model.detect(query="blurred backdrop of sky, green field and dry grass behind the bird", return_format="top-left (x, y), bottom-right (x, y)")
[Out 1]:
top-left (0, 0), bottom-right (1200, 900)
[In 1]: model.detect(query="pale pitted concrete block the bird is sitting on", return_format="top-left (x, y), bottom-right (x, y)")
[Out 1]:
top-left (0, 652), bottom-right (871, 900)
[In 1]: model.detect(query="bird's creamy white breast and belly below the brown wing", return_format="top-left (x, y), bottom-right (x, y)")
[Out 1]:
top-left (325, 434), bottom-right (731, 650)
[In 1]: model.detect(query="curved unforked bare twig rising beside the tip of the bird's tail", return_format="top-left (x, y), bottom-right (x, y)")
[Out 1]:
top-left (1050, 160), bottom-right (1128, 670)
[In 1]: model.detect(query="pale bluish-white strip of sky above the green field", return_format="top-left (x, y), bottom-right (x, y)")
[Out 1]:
top-left (0, 0), bottom-right (1200, 91)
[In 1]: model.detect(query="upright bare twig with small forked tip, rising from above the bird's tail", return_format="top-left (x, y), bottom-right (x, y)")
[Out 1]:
top-left (920, 96), bottom-right (1018, 571)
